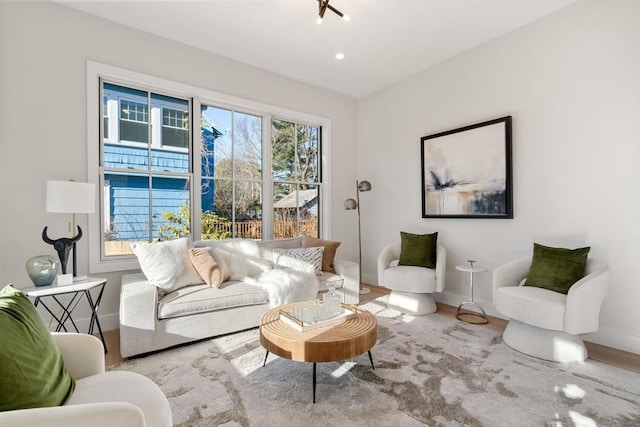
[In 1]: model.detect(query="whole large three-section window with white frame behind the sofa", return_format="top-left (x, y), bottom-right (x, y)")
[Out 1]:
top-left (87, 62), bottom-right (329, 272)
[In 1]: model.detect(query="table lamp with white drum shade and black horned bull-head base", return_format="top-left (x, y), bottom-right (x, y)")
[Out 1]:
top-left (42, 181), bottom-right (96, 280)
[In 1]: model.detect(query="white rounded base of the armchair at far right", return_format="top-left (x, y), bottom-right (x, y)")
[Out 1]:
top-left (502, 319), bottom-right (587, 363)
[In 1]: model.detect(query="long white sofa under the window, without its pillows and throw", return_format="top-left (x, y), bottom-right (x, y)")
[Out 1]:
top-left (120, 237), bottom-right (359, 358)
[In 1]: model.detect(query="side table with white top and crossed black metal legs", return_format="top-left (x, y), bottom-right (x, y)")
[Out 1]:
top-left (26, 277), bottom-right (107, 353)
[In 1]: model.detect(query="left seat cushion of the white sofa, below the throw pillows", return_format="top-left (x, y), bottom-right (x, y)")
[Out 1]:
top-left (158, 281), bottom-right (269, 319)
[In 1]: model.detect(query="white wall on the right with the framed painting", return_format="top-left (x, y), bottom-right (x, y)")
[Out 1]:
top-left (358, 1), bottom-right (640, 353)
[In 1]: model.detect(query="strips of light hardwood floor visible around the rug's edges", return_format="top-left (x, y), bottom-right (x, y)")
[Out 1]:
top-left (104, 285), bottom-right (640, 373)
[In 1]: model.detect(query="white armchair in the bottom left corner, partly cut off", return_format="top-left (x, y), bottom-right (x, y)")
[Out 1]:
top-left (0, 333), bottom-right (173, 427)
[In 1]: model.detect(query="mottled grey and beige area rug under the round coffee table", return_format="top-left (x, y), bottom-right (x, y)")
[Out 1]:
top-left (111, 301), bottom-right (640, 427)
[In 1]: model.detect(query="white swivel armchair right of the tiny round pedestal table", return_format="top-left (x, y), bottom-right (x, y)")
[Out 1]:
top-left (493, 257), bottom-right (609, 362)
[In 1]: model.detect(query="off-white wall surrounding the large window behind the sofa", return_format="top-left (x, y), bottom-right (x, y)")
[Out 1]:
top-left (0, 2), bottom-right (357, 329)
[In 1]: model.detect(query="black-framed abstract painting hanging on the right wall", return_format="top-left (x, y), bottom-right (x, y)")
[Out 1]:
top-left (420, 116), bottom-right (513, 219)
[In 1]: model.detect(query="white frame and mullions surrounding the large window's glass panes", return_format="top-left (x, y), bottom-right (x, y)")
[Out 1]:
top-left (87, 61), bottom-right (331, 273)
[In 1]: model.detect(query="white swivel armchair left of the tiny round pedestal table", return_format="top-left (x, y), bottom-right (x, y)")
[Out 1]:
top-left (378, 242), bottom-right (447, 315)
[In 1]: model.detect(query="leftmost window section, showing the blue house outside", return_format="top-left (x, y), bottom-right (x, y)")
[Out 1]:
top-left (100, 82), bottom-right (192, 257)
